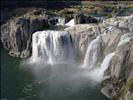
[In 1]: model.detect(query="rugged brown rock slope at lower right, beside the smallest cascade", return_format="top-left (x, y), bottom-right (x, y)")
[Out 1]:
top-left (101, 32), bottom-right (133, 100)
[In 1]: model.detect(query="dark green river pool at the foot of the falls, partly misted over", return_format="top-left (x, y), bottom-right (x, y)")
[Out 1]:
top-left (1, 49), bottom-right (108, 100)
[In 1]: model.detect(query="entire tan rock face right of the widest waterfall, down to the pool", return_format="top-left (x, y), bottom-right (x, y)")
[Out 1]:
top-left (65, 15), bottom-right (133, 100)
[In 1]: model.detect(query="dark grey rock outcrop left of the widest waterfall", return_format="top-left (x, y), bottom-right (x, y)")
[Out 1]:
top-left (1, 10), bottom-right (48, 58)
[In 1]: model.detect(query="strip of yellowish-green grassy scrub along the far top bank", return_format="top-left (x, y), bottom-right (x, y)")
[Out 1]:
top-left (48, 3), bottom-right (133, 18)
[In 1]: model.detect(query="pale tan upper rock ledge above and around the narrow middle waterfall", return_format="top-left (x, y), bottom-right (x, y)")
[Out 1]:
top-left (65, 15), bottom-right (133, 58)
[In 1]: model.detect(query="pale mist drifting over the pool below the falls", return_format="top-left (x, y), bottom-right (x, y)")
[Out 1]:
top-left (22, 59), bottom-right (105, 100)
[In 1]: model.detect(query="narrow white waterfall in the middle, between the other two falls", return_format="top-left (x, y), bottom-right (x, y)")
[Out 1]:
top-left (83, 36), bottom-right (104, 69)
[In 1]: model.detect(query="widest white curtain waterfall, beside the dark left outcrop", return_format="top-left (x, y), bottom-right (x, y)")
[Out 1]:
top-left (31, 30), bottom-right (74, 64)
